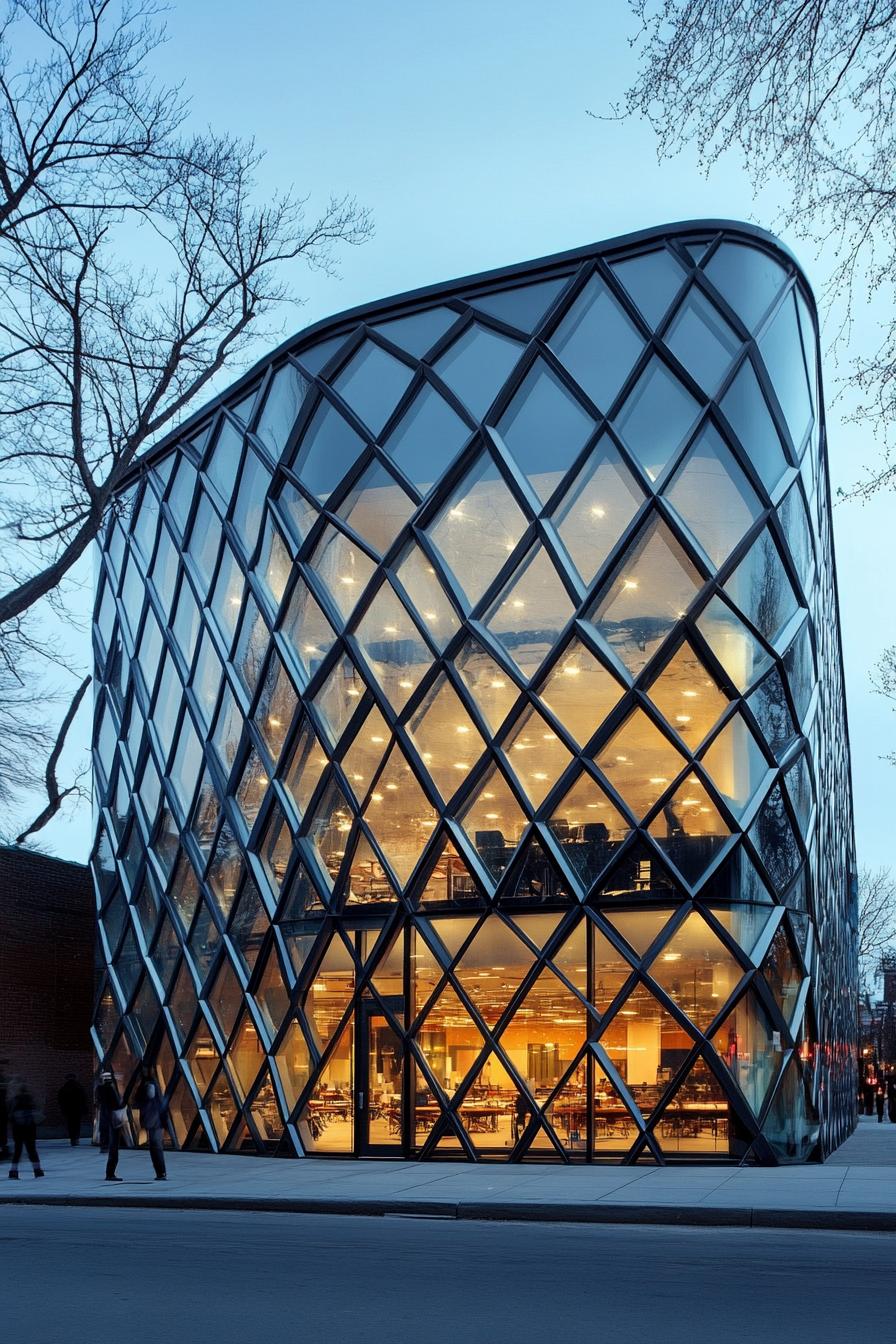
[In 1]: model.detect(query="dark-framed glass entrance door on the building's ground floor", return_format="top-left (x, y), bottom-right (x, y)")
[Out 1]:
top-left (355, 999), bottom-right (404, 1157)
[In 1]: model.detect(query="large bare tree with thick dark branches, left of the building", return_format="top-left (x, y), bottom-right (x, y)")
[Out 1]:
top-left (0, 0), bottom-right (371, 833)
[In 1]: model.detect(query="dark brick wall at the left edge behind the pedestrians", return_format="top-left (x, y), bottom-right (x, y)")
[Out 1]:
top-left (0, 847), bottom-right (94, 1134)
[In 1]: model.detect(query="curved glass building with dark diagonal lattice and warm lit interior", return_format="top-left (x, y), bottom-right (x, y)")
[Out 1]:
top-left (93, 222), bottom-right (856, 1163)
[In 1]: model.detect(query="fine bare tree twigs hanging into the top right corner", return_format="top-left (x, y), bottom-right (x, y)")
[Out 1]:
top-left (614, 0), bottom-right (896, 497)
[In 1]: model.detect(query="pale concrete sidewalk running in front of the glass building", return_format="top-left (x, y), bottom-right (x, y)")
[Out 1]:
top-left (0, 1118), bottom-right (896, 1231)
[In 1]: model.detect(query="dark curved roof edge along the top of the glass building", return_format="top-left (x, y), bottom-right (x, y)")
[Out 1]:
top-left (118, 219), bottom-right (818, 489)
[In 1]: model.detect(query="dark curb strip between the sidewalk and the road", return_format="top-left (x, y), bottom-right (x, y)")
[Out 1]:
top-left (0, 1193), bottom-right (896, 1232)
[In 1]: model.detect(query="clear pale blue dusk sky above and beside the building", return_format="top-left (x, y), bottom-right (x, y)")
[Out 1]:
top-left (15, 0), bottom-right (896, 866)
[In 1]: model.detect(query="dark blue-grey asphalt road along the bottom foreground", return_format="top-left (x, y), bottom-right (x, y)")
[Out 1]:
top-left (0, 1207), bottom-right (896, 1344)
